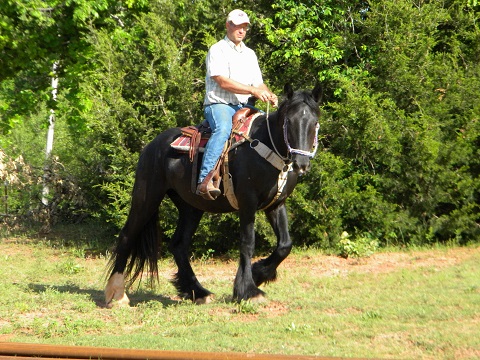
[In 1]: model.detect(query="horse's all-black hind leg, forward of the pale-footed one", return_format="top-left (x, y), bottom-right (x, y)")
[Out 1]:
top-left (169, 196), bottom-right (212, 304)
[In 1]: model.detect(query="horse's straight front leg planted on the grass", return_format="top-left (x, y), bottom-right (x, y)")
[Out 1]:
top-left (233, 210), bottom-right (265, 301)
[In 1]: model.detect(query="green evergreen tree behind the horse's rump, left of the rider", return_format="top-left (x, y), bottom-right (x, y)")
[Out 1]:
top-left (56, 2), bottom-right (208, 227)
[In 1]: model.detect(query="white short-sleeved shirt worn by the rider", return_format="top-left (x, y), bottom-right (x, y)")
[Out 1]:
top-left (204, 36), bottom-right (263, 105)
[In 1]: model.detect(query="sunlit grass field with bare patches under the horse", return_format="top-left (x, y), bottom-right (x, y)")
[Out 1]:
top-left (0, 237), bottom-right (480, 359)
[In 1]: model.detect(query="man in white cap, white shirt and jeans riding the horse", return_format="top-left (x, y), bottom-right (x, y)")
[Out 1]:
top-left (197, 9), bottom-right (278, 200)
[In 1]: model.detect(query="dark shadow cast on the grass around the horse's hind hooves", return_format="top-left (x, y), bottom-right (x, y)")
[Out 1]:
top-left (28, 284), bottom-right (182, 308)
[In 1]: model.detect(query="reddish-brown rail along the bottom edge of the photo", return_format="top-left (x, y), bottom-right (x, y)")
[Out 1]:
top-left (0, 342), bottom-right (371, 360)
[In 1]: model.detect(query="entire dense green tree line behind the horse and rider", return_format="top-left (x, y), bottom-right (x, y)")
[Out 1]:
top-left (0, 0), bottom-right (480, 251)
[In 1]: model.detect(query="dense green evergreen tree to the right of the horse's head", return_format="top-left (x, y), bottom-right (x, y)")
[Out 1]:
top-left (286, 1), bottom-right (480, 243)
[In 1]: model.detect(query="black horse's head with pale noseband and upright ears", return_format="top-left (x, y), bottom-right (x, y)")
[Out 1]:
top-left (279, 85), bottom-right (322, 176)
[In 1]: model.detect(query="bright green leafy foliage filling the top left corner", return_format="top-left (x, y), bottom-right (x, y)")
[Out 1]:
top-left (0, 0), bottom-right (119, 133)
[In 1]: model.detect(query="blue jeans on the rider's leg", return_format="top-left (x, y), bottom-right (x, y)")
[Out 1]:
top-left (198, 104), bottom-right (243, 183)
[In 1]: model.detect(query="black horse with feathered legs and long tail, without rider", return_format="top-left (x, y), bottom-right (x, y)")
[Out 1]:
top-left (105, 85), bottom-right (321, 307)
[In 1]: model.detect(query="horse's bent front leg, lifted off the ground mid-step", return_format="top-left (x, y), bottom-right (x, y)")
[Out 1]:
top-left (252, 204), bottom-right (292, 286)
